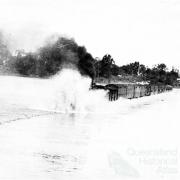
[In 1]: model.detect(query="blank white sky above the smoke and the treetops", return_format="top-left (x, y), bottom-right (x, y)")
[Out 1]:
top-left (0, 0), bottom-right (180, 68)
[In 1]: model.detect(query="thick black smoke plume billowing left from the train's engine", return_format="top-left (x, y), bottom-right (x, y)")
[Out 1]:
top-left (14, 37), bottom-right (95, 78)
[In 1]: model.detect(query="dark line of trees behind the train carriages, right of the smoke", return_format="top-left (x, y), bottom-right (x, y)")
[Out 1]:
top-left (95, 55), bottom-right (179, 85)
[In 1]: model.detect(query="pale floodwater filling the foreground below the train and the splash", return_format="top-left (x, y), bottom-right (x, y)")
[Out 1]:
top-left (0, 71), bottom-right (180, 180)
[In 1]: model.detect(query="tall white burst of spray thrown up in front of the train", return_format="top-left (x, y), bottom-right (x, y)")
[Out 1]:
top-left (52, 69), bottom-right (106, 113)
